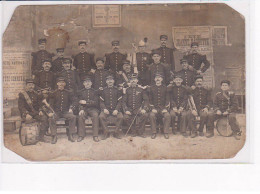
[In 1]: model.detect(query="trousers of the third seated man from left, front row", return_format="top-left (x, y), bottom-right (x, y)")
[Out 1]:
top-left (78, 108), bottom-right (99, 137)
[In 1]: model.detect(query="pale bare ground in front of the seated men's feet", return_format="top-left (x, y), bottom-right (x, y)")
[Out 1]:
top-left (4, 115), bottom-right (245, 161)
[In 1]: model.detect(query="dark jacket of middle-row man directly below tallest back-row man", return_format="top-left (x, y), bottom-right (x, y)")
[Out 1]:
top-left (148, 63), bottom-right (171, 85)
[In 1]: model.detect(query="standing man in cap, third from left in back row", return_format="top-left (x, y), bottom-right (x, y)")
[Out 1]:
top-left (73, 40), bottom-right (95, 81)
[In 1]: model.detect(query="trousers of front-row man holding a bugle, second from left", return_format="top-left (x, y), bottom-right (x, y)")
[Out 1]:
top-left (49, 112), bottom-right (77, 136)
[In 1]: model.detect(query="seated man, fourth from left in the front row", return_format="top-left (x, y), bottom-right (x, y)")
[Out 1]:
top-left (99, 75), bottom-right (123, 140)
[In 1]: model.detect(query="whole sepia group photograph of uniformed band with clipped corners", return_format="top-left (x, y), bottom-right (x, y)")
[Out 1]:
top-left (2, 3), bottom-right (247, 161)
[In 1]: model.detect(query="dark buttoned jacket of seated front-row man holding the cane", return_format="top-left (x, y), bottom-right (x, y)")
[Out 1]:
top-left (123, 86), bottom-right (149, 114)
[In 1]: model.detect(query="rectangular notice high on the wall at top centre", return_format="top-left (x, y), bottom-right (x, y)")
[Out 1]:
top-left (92, 5), bottom-right (121, 27)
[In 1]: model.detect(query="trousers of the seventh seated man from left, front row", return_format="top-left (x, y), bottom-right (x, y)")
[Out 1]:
top-left (170, 110), bottom-right (193, 133)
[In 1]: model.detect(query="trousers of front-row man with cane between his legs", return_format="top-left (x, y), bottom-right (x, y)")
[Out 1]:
top-left (124, 113), bottom-right (148, 135)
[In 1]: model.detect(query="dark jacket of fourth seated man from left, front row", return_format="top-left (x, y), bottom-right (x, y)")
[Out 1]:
top-left (100, 87), bottom-right (122, 112)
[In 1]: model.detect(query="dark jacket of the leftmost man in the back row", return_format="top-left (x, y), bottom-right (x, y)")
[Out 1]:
top-left (31, 50), bottom-right (54, 75)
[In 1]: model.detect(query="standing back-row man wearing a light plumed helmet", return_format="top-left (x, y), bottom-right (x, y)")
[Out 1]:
top-left (136, 40), bottom-right (152, 86)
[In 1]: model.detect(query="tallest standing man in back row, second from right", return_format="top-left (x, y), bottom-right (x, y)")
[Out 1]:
top-left (152, 35), bottom-right (175, 72)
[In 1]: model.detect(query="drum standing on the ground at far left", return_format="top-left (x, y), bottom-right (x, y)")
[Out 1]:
top-left (19, 122), bottom-right (40, 146)
